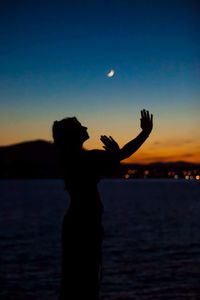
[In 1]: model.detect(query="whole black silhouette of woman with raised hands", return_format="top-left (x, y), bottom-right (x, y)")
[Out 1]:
top-left (53, 110), bottom-right (153, 300)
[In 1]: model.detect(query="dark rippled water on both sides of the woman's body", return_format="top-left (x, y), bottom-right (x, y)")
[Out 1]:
top-left (0, 180), bottom-right (200, 300)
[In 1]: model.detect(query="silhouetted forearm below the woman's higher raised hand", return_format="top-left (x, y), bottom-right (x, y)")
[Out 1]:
top-left (120, 130), bottom-right (150, 160)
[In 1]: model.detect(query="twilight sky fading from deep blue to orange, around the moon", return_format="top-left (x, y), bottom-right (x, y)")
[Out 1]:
top-left (0, 0), bottom-right (200, 163)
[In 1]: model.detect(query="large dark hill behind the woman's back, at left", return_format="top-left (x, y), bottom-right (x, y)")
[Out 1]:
top-left (0, 140), bottom-right (60, 178)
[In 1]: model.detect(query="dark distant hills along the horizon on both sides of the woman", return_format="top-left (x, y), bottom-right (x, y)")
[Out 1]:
top-left (0, 140), bottom-right (200, 179)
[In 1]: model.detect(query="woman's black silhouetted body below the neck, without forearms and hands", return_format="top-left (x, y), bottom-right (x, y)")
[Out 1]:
top-left (60, 150), bottom-right (118, 300)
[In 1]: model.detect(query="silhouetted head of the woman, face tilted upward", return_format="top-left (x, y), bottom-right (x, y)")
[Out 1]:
top-left (52, 117), bottom-right (89, 149)
